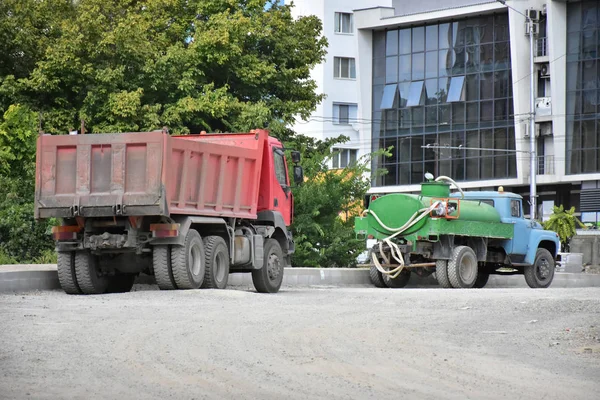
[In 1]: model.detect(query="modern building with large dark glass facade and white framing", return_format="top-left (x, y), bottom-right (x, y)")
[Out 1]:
top-left (352, 0), bottom-right (600, 223)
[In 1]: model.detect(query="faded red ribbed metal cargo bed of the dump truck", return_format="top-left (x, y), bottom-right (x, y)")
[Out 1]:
top-left (35, 130), bottom-right (267, 219)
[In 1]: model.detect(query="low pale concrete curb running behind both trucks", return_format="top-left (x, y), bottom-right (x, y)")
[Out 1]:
top-left (0, 264), bottom-right (600, 293)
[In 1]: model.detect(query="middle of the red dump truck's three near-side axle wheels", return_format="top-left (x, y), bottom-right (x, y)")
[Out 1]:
top-left (202, 236), bottom-right (229, 289)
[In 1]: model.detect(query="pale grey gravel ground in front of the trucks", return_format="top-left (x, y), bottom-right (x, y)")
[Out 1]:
top-left (0, 285), bottom-right (600, 400)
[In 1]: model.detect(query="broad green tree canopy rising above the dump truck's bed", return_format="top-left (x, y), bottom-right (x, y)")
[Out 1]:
top-left (0, 0), bottom-right (326, 133)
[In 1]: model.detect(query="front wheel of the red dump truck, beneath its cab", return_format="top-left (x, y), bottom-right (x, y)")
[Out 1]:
top-left (252, 239), bottom-right (285, 293)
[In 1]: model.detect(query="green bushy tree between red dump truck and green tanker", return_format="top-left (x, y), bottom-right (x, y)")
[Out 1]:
top-left (285, 135), bottom-right (384, 268)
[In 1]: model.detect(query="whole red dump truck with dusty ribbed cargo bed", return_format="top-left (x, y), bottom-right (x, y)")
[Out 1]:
top-left (35, 130), bottom-right (303, 294)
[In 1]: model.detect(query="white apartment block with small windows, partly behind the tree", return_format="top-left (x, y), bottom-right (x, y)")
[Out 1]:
top-left (292, 0), bottom-right (392, 168)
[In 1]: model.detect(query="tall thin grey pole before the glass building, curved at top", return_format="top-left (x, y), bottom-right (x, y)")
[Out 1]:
top-left (496, 0), bottom-right (537, 221)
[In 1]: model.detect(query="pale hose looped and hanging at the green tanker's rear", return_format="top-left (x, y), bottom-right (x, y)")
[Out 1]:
top-left (363, 201), bottom-right (441, 279)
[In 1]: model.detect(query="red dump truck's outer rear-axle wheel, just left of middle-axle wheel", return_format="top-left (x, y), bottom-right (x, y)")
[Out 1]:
top-left (171, 229), bottom-right (205, 289)
